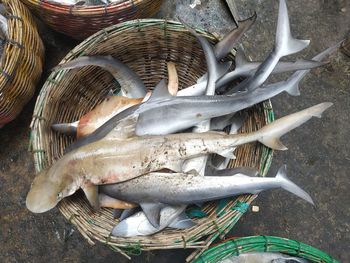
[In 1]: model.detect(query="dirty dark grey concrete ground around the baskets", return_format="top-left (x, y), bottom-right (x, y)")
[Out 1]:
top-left (0, 0), bottom-right (350, 263)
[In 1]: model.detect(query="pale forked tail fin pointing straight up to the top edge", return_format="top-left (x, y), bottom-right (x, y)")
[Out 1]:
top-left (276, 0), bottom-right (310, 56)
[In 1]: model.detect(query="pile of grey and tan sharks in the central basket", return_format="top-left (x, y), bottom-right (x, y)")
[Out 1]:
top-left (26, 0), bottom-right (339, 237)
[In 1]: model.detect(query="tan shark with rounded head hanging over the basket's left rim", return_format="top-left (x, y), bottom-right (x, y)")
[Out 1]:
top-left (26, 102), bottom-right (332, 216)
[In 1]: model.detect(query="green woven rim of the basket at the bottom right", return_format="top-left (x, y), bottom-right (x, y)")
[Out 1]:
top-left (193, 236), bottom-right (339, 263)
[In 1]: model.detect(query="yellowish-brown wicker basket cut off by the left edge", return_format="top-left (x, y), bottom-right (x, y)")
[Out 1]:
top-left (0, 0), bottom-right (44, 127)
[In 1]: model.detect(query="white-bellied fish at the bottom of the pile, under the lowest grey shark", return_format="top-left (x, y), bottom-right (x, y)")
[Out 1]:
top-left (111, 205), bottom-right (194, 237)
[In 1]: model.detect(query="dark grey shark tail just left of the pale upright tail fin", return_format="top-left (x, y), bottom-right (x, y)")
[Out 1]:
top-left (214, 13), bottom-right (257, 60)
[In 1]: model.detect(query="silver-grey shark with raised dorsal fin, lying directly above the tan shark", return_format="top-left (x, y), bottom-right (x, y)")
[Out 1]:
top-left (65, 67), bottom-right (314, 153)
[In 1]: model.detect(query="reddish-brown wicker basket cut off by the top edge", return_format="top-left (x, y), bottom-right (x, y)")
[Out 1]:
top-left (22, 0), bottom-right (162, 40)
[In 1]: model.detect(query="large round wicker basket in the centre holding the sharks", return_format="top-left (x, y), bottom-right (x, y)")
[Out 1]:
top-left (31, 19), bottom-right (273, 262)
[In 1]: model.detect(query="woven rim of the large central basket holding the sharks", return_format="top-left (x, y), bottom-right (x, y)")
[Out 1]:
top-left (31, 19), bottom-right (274, 262)
